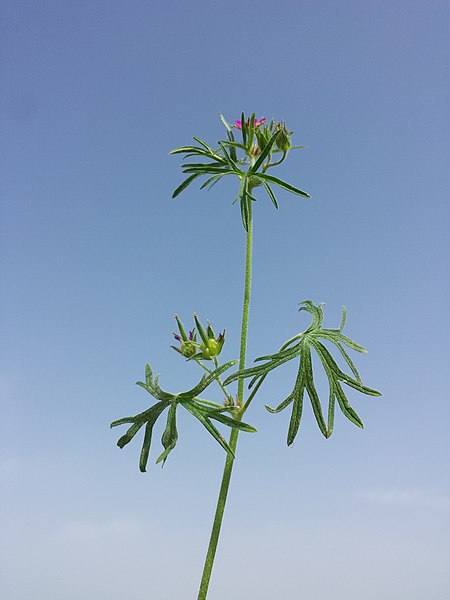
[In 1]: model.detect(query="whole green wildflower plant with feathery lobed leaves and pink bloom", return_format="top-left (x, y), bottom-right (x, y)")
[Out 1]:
top-left (111, 113), bottom-right (380, 600)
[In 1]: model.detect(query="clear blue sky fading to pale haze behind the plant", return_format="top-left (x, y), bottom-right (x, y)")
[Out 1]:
top-left (0, 0), bottom-right (450, 600)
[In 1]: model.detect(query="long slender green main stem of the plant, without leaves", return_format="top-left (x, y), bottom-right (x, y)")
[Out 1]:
top-left (197, 201), bottom-right (253, 600)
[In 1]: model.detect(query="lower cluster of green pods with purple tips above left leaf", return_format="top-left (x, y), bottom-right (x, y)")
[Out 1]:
top-left (171, 314), bottom-right (225, 360)
